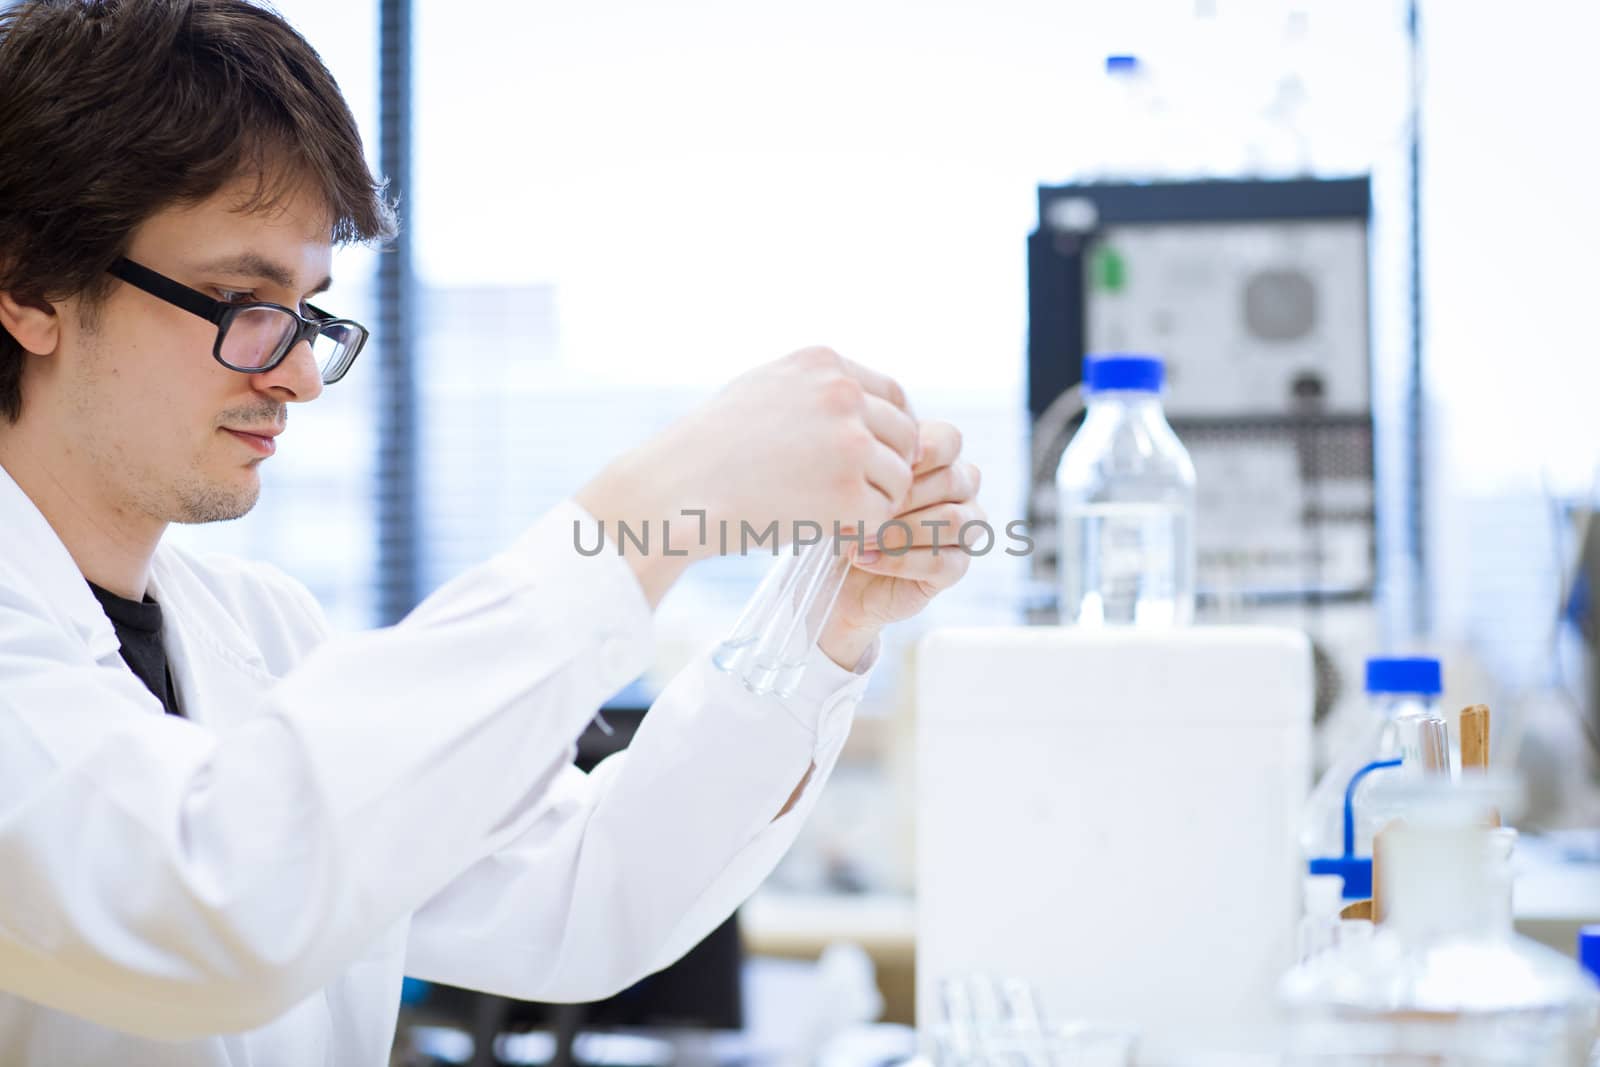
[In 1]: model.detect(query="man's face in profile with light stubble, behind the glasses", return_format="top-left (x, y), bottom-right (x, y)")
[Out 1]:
top-left (51, 178), bottom-right (333, 523)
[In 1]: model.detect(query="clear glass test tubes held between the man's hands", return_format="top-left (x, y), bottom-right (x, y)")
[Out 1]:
top-left (712, 541), bottom-right (851, 696)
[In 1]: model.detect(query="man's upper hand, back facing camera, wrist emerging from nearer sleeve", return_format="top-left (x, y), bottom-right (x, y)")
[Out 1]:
top-left (576, 349), bottom-right (917, 605)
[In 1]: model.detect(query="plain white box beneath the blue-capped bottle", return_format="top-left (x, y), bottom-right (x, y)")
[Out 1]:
top-left (917, 627), bottom-right (1312, 1037)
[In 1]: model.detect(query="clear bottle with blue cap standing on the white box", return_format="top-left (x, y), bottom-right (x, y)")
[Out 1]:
top-left (1056, 354), bottom-right (1195, 627)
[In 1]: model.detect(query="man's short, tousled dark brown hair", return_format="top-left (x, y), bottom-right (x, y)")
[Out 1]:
top-left (0, 0), bottom-right (395, 422)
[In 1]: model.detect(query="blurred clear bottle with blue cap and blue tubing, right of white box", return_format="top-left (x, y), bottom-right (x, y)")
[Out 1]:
top-left (1301, 656), bottom-right (1443, 901)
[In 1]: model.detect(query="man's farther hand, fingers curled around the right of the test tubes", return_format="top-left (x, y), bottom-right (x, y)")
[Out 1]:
top-left (818, 422), bottom-right (987, 670)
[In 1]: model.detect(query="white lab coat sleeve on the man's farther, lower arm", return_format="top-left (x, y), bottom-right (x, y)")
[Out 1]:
top-left (406, 633), bottom-right (877, 1001)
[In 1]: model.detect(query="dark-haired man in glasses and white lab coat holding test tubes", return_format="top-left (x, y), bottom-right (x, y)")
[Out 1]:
top-left (0, 0), bottom-right (981, 1067)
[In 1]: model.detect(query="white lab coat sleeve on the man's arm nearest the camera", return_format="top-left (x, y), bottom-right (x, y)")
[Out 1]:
top-left (0, 504), bottom-right (650, 1040)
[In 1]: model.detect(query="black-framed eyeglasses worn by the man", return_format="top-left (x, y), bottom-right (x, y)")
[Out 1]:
top-left (110, 259), bottom-right (368, 386)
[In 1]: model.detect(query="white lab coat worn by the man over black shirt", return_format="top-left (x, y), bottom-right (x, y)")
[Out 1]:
top-left (0, 469), bottom-right (870, 1067)
